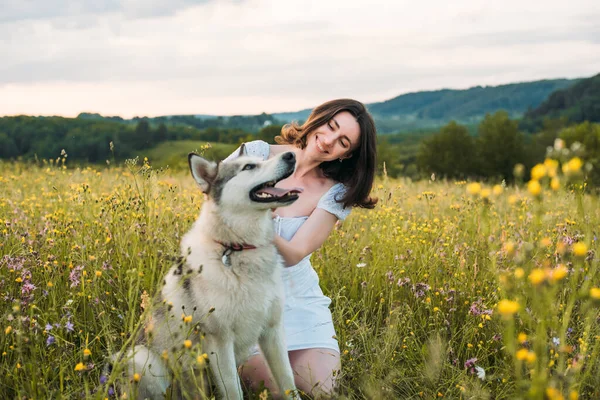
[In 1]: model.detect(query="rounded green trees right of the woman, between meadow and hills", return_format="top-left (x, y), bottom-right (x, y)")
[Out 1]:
top-left (415, 111), bottom-right (600, 186)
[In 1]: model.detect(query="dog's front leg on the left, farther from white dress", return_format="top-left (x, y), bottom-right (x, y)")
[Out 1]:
top-left (204, 336), bottom-right (243, 400)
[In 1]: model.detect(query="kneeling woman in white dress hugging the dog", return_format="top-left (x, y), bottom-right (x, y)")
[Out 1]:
top-left (225, 99), bottom-right (377, 397)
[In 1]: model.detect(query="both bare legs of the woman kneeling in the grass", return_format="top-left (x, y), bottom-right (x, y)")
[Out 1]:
top-left (240, 348), bottom-right (341, 398)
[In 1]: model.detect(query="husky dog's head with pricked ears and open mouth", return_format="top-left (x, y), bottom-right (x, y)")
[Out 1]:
top-left (188, 152), bottom-right (302, 210)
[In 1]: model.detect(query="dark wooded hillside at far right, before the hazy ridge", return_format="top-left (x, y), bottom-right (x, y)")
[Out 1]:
top-left (522, 74), bottom-right (600, 130)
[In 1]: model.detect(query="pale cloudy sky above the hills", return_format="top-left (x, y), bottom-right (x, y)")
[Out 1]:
top-left (0, 0), bottom-right (600, 118)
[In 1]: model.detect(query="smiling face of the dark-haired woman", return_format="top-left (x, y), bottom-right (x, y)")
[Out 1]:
top-left (305, 111), bottom-right (360, 161)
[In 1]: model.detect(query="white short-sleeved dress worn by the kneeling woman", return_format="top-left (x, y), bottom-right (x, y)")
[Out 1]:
top-left (224, 140), bottom-right (351, 354)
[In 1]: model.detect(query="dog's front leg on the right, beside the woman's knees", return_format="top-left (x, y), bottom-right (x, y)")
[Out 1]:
top-left (258, 323), bottom-right (299, 399)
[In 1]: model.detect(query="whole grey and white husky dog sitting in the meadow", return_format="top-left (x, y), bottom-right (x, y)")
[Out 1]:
top-left (113, 149), bottom-right (301, 399)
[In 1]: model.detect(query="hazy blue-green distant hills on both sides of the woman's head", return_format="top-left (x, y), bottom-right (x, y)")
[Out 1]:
top-left (78, 79), bottom-right (579, 133)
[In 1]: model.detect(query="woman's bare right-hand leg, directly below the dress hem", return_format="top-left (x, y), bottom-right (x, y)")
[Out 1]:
top-left (289, 348), bottom-right (341, 398)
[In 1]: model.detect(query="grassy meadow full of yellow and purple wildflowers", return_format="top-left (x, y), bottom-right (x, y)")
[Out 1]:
top-left (0, 152), bottom-right (600, 400)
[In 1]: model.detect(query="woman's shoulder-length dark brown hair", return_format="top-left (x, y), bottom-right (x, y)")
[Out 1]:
top-left (275, 99), bottom-right (377, 208)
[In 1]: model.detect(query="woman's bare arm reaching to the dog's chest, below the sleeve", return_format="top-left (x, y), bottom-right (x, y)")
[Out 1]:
top-left (275, 208), bottom-right (338, 267)
